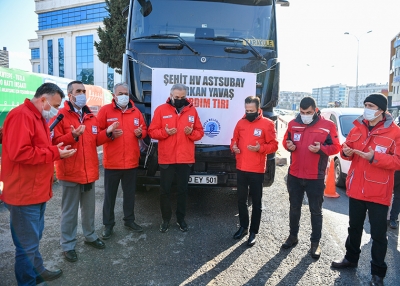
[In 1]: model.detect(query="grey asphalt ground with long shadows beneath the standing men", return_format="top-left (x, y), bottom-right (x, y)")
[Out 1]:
top-left (0, 117), bottom-right (400, 286)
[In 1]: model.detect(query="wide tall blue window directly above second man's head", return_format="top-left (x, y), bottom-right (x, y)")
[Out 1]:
top-left (76, 35), bottom-right (94, 84)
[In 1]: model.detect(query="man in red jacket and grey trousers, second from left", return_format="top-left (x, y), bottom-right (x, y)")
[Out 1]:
top-left (50, 81), bottom-right (118, 262)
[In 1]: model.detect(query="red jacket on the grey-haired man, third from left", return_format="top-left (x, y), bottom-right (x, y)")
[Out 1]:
top-left (97, 100), bottom-right (147, 169)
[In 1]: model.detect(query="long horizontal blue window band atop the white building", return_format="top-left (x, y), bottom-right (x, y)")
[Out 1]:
top-left (39, 3), bottom-right (108, 30)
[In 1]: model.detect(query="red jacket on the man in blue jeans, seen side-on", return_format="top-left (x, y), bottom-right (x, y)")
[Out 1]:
top-left (0, 99), bottom-right (60, 206)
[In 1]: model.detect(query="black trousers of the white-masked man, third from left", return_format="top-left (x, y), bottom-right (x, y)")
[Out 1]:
top-left (103, 168), bottom-right (137, 227)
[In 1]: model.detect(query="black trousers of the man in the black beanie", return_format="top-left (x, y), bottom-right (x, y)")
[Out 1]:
top-left (346, 198), bottom-right (389, 277)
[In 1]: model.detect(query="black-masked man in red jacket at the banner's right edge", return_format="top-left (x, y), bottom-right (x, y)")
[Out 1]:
top-left (231, 96), bottom-right (278, 246)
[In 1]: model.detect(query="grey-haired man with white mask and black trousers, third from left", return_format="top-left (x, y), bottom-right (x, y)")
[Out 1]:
top-left (97, 83), bottom-right (147, 239)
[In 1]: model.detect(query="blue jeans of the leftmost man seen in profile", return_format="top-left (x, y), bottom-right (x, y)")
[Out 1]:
top-left (5, 203), bottom-right (46, 285)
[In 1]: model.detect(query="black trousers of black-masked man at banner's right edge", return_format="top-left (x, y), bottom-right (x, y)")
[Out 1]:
top-left (237, 170), bottom-right (264, 234)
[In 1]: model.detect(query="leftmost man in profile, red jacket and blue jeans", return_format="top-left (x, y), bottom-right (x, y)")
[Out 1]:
top-left (0, 83), bottom-right (76, 285)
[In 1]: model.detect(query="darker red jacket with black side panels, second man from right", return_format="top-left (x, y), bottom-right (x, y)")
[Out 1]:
top-left (282, 115), bottom-right (340, 179)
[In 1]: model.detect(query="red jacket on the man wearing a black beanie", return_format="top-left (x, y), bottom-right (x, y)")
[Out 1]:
top-left (340, 113), bottom-right (400, 206)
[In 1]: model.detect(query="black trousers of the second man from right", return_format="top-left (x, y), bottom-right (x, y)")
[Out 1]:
top-left (287, 174), bottom-right (325, 242)
